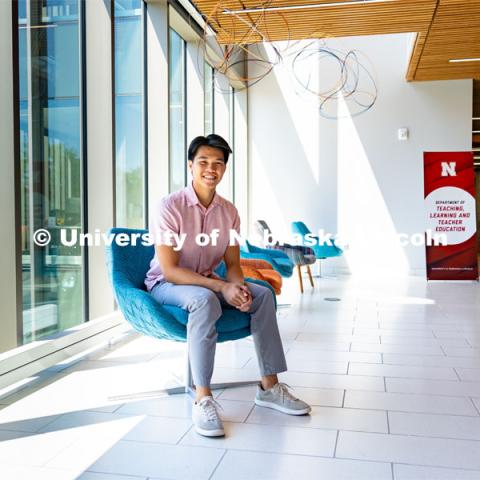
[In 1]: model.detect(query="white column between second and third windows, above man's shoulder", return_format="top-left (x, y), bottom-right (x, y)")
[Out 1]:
top-left (146, 0), bottom-right (169, 214)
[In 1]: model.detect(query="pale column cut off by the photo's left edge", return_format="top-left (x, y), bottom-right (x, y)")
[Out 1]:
top-left (0, 2), bottom-right (22, 353)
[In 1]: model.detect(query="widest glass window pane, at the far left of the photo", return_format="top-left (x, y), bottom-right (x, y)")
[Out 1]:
top-left (18, 0), bottom-right (85, 343)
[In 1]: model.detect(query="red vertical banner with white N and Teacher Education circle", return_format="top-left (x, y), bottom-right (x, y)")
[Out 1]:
top-left (423, 152), bottom-right (478, 280)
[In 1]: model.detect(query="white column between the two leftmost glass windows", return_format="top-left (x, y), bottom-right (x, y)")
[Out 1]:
top-left (85, 0), bottom-right (115, 319)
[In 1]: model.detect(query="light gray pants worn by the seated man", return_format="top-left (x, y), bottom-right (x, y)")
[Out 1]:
top-left (151, 281), bottom-right (287, 387)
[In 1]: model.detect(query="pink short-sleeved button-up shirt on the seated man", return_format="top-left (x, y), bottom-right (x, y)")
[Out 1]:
top-left (145, 183), bottom-right (240, 291)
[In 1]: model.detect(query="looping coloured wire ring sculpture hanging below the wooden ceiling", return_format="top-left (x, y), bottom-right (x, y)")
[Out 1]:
top-left (195, 0), bottom-right (378, 119)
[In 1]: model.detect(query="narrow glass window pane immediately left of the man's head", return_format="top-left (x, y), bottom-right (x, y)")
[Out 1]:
top-left (168, 29), bottom-right (187, 192)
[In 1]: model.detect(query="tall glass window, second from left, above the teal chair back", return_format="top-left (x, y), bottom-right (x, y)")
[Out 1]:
top-left (114, 0), bottom-right (145, 228)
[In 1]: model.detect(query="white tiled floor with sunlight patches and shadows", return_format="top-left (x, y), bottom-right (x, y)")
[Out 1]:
top-left (0, 277), bottom-right (480, 480)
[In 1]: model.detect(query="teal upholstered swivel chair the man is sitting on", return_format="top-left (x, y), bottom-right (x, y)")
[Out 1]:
top-left (106, 228), bottom-right (276, 395)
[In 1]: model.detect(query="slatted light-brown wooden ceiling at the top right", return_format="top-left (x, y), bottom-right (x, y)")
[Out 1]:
top-left (191, 0), bottom-right (480, 81)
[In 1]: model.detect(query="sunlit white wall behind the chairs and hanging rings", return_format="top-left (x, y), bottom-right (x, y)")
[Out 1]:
top-left (248, 34), bottom-right (472, 275)
